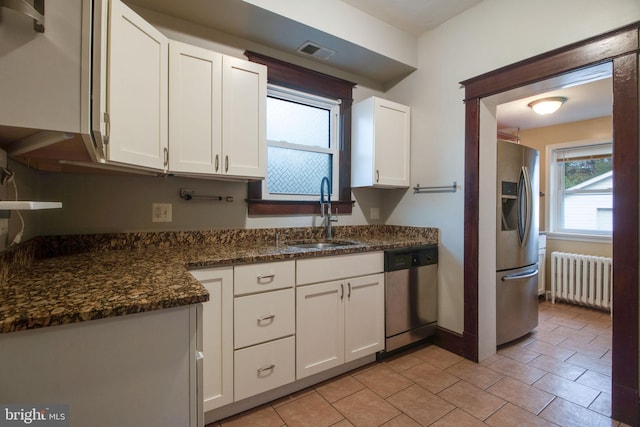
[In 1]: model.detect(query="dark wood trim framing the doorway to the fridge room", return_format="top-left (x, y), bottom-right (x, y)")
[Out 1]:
top-left (462, 23), bottom-right (640, 425)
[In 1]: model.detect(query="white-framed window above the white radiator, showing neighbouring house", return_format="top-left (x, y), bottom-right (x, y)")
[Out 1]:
top-left (550, 142), bottom-right (613, 236)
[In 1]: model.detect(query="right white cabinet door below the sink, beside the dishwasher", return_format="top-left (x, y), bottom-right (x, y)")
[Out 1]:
top-left (344, 274), bottom-right (384, 362)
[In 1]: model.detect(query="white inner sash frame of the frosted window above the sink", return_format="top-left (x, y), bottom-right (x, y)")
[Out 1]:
top-left (262, 84), bottom-right (341, 201)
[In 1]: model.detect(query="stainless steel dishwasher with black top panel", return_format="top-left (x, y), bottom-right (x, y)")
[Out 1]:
top-left (384, 245), bottom-right (438, 352)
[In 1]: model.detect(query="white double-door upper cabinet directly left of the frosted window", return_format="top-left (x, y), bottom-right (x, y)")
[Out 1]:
top-left (169, 41), bottom-right (267, 178)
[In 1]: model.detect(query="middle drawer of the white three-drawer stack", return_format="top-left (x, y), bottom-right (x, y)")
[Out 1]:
top-left (233, 288), bottom-right (295, 348)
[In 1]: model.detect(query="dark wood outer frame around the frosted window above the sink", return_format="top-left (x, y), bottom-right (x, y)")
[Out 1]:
top-left (245, 51), bottom-right (355, 215)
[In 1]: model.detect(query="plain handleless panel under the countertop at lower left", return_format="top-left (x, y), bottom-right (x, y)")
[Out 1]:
top-left (0, 306), bottom-right (202, 427)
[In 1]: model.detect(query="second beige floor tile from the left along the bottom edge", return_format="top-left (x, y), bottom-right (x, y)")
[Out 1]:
top-left (276, 392), bottom-right (344, 427)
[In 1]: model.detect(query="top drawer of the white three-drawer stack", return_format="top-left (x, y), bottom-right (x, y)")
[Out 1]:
top-left (234, 261), bottom-right (296, 295)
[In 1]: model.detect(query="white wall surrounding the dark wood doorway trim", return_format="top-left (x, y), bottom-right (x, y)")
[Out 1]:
top-left (387, 0), bottom-right (640, 358)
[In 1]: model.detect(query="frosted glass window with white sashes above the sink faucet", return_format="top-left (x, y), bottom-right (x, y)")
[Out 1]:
top-left (262, 85), bottom-right (340, 200)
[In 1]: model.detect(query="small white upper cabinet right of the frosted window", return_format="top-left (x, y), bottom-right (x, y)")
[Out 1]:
top-left (351, 97), bottom-right (411, 188)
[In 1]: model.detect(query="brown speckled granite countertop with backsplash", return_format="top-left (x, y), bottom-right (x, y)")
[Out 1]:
top-left (0, 226), bottom-right (438, 333)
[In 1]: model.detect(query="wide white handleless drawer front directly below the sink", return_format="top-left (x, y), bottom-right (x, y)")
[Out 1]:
top-left (296, 252), bottom-right (384, 285)
